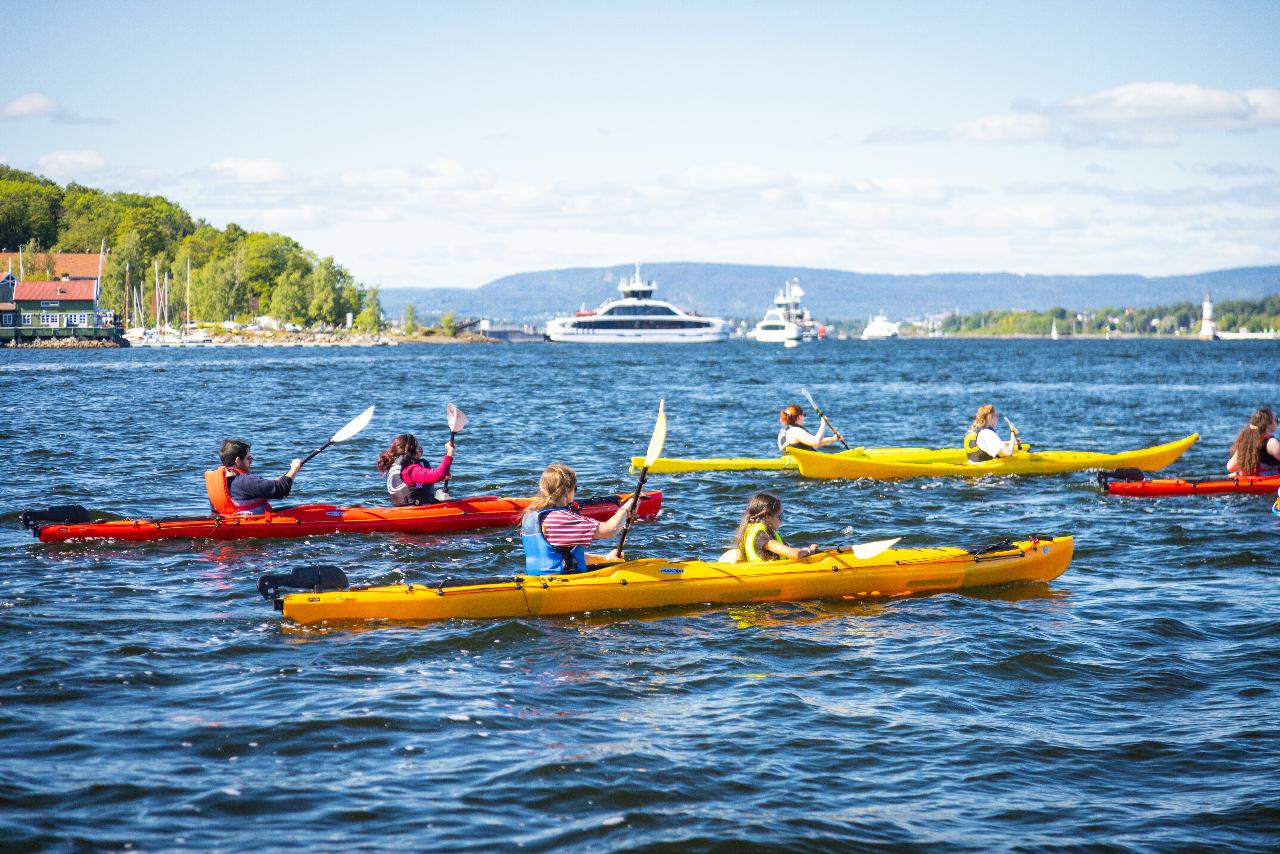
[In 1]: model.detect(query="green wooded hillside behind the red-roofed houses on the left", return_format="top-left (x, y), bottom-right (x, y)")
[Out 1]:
top-left (0, 164), bottom-right (383, 332)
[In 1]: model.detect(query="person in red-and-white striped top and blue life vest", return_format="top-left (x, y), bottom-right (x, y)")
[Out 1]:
top-left (520, 462), bottom-right (635, 575)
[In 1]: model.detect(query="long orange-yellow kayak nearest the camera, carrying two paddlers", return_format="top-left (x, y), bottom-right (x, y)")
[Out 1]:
top-left (275, 536), bottom-right (1074, 625)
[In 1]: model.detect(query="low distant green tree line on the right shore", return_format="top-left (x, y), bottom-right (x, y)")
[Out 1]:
top-left (941, 294), bottom-right (1280, 335)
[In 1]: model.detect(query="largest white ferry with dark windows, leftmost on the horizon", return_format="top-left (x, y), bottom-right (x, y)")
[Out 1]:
top-left (547, 264), bottom-right (730, 344)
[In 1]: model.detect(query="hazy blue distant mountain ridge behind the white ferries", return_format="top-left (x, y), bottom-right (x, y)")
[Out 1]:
top-left (379, 262), bottom-right (1280, 323)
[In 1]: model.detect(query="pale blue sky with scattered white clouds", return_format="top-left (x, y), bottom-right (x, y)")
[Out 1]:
top-left (0, 0), bottom-right (1280, 287)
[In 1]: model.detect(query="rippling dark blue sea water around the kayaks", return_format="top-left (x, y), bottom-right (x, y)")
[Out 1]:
top-left (0, 341), bottom-right (1280, 850)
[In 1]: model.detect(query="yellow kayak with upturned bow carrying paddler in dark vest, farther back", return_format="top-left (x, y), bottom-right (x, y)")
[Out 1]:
top-left (787, 433), bottom-right (1199, 480)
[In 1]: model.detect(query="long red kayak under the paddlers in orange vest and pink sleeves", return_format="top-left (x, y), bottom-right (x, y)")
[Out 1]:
top-left (22, 492), bottom-right (662, 543)
